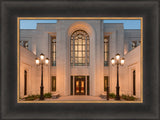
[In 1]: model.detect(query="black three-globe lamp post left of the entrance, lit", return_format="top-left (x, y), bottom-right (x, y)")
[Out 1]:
top-left (35, 53), bottom-right (49, 100)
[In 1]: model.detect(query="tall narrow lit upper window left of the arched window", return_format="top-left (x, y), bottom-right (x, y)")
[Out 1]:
top-left (51, 37), bottom-right (56, 66)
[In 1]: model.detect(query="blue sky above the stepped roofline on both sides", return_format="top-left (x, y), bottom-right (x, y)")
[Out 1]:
top-left (20, 20), bottom-right (141, 29)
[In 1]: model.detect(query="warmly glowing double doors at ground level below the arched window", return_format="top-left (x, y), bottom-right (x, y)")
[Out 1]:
top-left (75, 76), bottom-right (85, 95)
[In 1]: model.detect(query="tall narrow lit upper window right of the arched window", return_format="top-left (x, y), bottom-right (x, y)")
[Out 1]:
top-left (104, 36), bottom-right (109, 66)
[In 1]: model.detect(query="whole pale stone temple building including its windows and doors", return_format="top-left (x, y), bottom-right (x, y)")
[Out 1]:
top-left (19, 20), bottom-right (142, 98)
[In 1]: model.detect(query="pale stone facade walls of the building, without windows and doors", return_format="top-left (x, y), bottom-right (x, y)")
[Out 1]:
top-left (20, 20), bottom-right (141, 98)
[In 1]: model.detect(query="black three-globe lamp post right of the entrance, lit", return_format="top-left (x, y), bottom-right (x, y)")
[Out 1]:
top-left (111, 54), bottom-right (124, 100)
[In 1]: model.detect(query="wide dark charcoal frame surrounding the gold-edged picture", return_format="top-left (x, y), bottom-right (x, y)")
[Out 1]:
top-left (0, 0), bottom-right (160, 120)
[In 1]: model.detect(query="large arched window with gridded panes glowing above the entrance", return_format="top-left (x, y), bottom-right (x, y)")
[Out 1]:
top-left (70, 30), bottom-right (90, 66)
